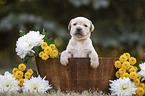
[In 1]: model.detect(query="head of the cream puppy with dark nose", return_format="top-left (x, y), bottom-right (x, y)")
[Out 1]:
top-left (68, 17), bottom-right (94, 40)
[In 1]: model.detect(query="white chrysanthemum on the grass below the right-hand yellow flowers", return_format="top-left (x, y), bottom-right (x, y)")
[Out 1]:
top-left (109, 78), bottom-right (137, 96)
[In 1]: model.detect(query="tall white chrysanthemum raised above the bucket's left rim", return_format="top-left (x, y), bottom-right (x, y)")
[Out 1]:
top-left (16, 31), bottom-right (45, 59)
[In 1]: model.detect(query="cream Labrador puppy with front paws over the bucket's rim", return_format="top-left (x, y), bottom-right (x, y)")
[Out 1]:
top-left (60, 17), bottom-right (99, 68)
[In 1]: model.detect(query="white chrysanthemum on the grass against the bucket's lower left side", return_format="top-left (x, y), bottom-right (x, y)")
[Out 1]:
top-left (23, 76), bottom-right (52, 93)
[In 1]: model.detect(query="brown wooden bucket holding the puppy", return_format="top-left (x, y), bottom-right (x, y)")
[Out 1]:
top-left (36, 57), bottom-right (116, 92)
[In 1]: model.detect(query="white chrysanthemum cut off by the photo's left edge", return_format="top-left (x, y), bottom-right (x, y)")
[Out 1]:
top-left (0, 71), bottom-right (20, 93)
